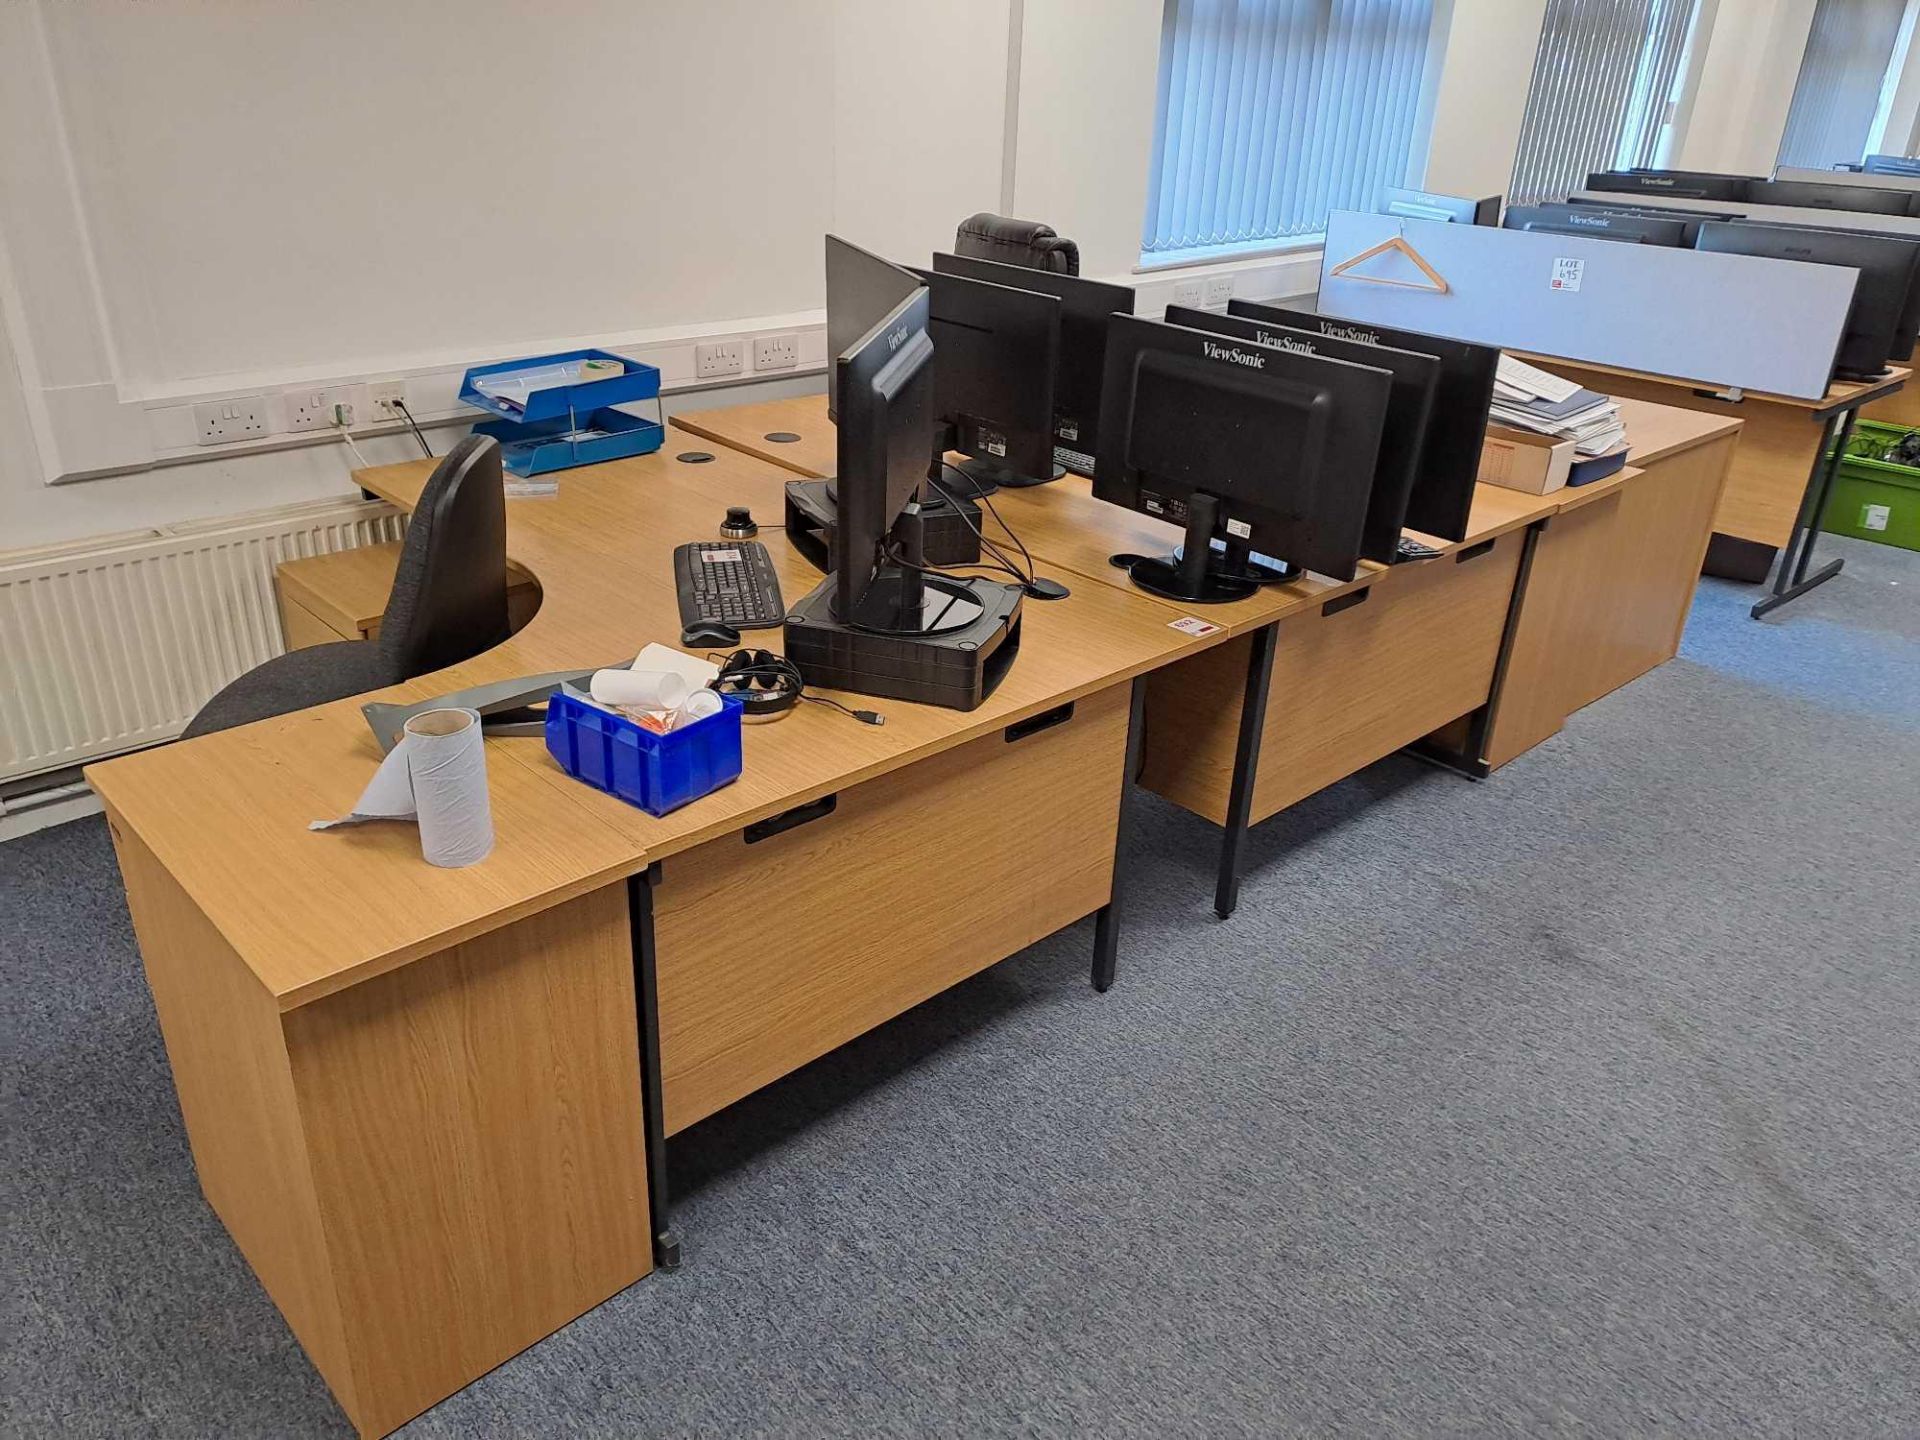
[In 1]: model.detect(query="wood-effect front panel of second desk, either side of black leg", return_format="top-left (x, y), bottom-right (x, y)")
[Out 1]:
top-left (1140, 532), bottom-right (1524, 826)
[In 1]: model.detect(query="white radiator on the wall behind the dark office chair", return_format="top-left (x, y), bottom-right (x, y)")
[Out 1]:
top-left (0, 499), bottom-right (405, 781)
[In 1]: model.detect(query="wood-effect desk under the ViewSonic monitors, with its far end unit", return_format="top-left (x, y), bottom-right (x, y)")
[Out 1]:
top-left (672, 396), bottom-right (1740, 918)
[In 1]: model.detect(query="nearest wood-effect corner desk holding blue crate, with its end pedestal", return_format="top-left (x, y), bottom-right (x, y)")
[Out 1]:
top-left (88, 451), bottom-right (1221, 1434)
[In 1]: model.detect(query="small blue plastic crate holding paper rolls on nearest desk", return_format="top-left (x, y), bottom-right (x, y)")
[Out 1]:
top-left (547, 689), bottom-right (743, 814)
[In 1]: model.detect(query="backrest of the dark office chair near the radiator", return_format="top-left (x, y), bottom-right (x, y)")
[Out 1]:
top-left (380, 436), bottom-right (509, 680)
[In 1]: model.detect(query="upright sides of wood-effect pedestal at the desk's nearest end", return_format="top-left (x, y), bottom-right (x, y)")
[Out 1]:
top-left (109, 814), bottom-right (653, 1436)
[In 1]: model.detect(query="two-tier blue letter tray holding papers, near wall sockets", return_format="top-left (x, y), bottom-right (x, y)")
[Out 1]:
top-left (461, 349), bottom-right (666, 476)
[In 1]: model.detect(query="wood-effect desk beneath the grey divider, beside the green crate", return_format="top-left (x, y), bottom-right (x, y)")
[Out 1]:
top-left (1530, 355), bottom-right (1912, 582)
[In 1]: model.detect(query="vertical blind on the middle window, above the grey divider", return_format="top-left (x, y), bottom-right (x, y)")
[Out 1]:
top-left (1507, 0), bottom-right (1699, 204)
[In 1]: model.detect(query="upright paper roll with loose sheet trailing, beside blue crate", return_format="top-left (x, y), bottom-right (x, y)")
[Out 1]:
top-left (309, 710), bottom-right (493, 868)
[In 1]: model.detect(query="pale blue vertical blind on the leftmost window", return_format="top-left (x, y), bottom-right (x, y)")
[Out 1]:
top-left (1140, 0), bottom-right (1432, 255)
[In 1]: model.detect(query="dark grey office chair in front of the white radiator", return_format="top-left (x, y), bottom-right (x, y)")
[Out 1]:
top-left (180, 436), bottom-right (509, 739)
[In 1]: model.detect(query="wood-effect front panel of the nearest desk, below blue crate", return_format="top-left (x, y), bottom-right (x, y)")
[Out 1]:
top-left (653, 685), bottom-right (1129, 1135)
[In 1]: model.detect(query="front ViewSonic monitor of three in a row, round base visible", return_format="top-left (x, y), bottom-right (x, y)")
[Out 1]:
top-left (1092, 315), bottom-right (1392, 605)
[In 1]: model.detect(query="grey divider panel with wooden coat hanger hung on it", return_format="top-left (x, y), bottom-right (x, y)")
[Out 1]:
top-left (1319, 211), bottom-right (1857, 399)
